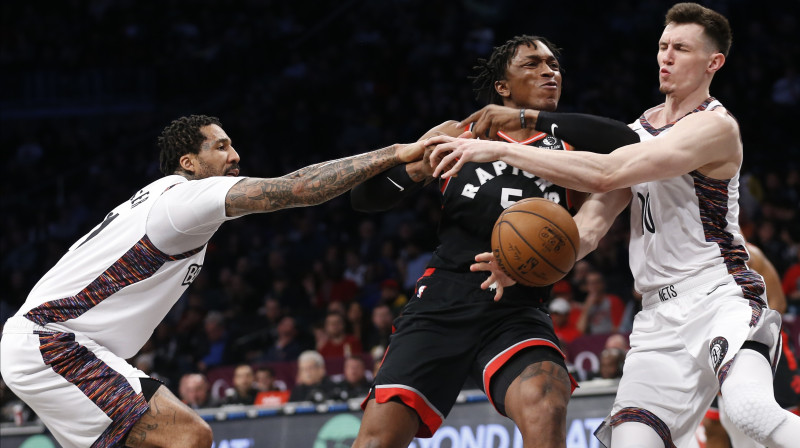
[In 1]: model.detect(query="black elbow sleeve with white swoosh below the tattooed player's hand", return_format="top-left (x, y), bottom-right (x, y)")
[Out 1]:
top-left (350, 164), bottom-right (425, 212)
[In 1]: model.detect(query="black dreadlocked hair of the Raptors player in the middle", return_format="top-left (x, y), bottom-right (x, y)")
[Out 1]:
top-left (470, 34), bottom-right (561, 104)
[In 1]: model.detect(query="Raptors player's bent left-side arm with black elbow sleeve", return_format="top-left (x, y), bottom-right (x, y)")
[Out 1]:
top-left (350, 121), bottom-right (462, 212)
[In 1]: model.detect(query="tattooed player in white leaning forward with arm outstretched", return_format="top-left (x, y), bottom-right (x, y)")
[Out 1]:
top-left (0, 115), bottom-right (423, 448)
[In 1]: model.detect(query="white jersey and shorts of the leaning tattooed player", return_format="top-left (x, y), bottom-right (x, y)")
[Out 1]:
top-left (0, 175), bottom-right (241, 447)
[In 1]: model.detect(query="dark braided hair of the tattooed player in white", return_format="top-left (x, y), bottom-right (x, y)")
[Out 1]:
top-left (158, 115), bottom-right (222, 175)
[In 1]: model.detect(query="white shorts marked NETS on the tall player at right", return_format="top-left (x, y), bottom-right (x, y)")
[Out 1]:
top-left (595, 267), bottom-right (775, 448)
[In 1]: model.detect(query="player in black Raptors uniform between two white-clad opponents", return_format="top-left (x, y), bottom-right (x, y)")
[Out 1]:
top-left (351, 36), bottom-right (638, 447)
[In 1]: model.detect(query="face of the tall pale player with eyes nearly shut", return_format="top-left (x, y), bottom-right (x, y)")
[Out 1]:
top-left (658, 23), bottom-right (721, 95)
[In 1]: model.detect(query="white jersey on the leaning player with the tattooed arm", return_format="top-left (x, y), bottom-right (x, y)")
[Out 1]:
top-left (16, 176), bottom-right (241, 358)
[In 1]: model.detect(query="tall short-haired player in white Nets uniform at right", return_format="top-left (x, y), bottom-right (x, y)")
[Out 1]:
top-left (429, 3), bottom-right (800, 448)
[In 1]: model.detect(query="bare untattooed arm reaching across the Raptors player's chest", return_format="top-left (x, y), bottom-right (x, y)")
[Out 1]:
top-left (427, 111), bottom-right (742, 193)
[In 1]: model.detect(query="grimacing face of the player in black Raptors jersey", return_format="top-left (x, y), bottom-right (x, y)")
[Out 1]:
top-left (495, 41), bottom-right (561, 111)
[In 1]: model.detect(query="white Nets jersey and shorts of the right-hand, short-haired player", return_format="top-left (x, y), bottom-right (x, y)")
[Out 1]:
top-left (596, 98), bottom-right (774, 447)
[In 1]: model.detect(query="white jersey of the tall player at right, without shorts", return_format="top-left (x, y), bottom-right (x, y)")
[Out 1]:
top-left (630, 98), bottom-right (764, 302)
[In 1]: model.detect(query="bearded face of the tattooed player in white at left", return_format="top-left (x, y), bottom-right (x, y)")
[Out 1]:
top-left (194, 124), bottom-right (239, 179)
